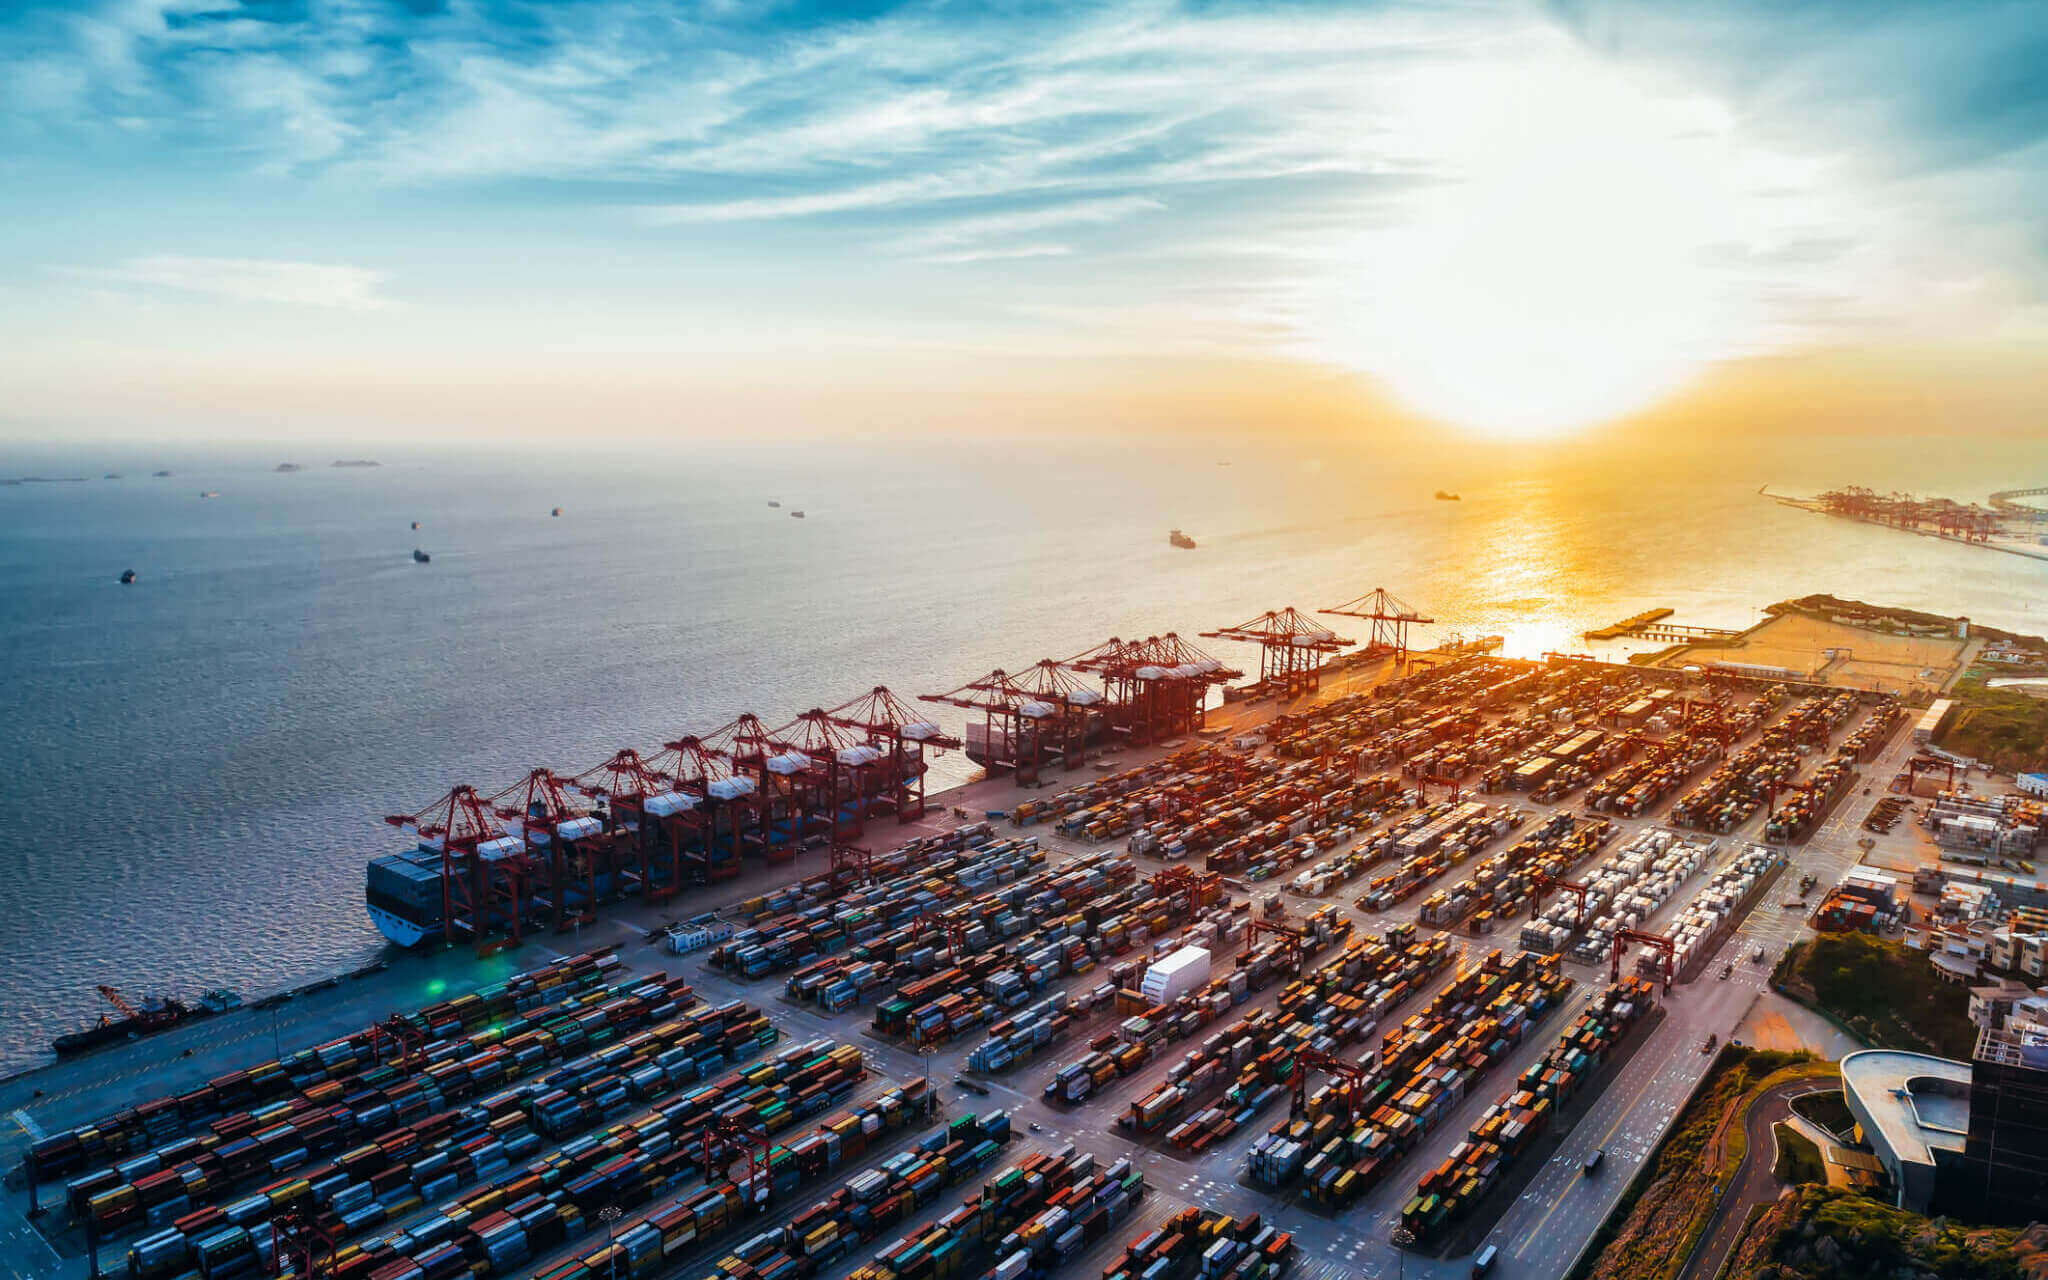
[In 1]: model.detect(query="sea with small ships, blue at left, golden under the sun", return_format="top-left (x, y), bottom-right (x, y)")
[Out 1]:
top-left (0, 436), bottom-right (2048, 1069)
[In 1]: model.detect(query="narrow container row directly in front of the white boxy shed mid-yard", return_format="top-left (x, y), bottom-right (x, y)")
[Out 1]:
top-left (1044, 909), bottom-right (1376, 1104)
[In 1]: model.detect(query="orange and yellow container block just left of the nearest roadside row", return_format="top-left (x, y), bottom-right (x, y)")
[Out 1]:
top-left (1245, 952), bottom-right (1573, 1210)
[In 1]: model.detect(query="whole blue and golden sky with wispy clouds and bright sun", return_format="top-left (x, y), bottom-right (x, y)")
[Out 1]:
top-left (0, 0), bottom-right (2048, 440)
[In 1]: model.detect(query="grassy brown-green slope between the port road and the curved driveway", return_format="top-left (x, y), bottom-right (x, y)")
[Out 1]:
top-left (1577, 1044), bottom-right (1835, 1280)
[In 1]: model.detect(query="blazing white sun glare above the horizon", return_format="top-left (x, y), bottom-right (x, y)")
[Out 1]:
top-left (1313, 47), bottom-right (1751, 436)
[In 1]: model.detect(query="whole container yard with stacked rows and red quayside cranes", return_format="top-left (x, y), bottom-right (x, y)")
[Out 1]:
top-left (8, 622), bottom-right (1905, 1280)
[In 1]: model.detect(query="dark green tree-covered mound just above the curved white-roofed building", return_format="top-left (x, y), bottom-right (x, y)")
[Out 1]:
top-left (1784, 934), bottom-right (1976, 1059)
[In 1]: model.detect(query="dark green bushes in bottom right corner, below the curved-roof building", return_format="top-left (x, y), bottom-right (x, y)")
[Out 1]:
top-left (1729, 1186), bottom-right (2048, 1280)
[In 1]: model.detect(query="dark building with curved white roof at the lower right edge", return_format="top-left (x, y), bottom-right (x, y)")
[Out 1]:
top-left (1841, 1028), bottom-right (2048, 1225)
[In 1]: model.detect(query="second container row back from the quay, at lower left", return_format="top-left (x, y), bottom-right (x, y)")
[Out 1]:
top-left (66, 975), bottom-right (690, 1237)
